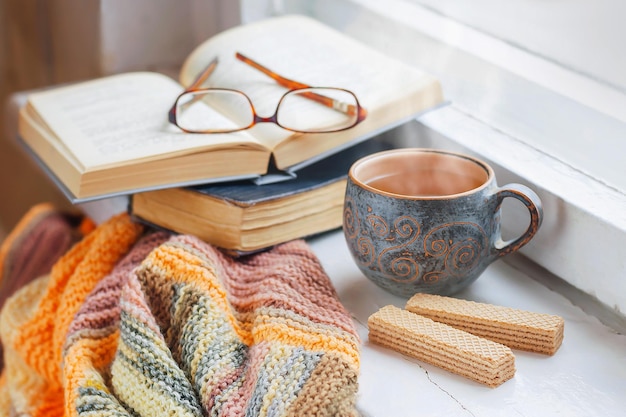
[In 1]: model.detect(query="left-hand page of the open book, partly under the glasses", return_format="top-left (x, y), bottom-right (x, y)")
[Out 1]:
top-left (28, 72), bottom-right (262, 169)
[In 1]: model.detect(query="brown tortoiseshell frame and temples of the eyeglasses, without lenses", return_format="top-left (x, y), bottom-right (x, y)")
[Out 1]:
top-left (168, 52), bottom-right (367, 134)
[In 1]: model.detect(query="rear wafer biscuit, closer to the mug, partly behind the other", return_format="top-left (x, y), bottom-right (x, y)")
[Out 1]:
top-left (406, 294), bottom-right (564, 355)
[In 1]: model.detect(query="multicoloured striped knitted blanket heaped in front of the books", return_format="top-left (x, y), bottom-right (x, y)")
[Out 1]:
top-left (0, 214), bottom-right (359, 416)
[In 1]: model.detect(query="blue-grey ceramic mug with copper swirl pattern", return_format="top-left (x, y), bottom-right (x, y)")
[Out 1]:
top-left (343, 148), bottom-right (543, 298)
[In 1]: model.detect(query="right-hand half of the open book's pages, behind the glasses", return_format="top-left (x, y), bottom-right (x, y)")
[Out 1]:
top-left (180, 15), bottom-right (442, 166)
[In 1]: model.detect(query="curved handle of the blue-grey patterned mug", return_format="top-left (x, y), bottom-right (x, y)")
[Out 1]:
top-left (495, 183), bottom-right (543, 257)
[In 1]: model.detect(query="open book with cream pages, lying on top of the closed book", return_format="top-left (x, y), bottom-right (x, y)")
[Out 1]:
top-left (19, 15), bottom-right (442, 202)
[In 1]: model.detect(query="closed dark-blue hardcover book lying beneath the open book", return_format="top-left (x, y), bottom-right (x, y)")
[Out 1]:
top-left (129, 127), bottom-right (403, 254)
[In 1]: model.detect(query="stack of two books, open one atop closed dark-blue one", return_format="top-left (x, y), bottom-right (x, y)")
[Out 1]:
top-left (19, 15), bottom-right (443, 253)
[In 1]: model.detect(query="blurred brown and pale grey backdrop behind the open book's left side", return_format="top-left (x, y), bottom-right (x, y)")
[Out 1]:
top-left (0, 0), bottom-right (240, 237)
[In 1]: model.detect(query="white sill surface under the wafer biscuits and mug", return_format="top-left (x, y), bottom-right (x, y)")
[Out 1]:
top-left (310, 232), bottom-right (626, 417)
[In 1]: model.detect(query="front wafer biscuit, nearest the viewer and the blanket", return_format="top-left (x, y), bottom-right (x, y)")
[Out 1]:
top-left (368, 305), bottom-right (515, 387)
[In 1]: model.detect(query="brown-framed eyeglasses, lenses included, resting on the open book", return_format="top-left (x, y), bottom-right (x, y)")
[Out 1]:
top-left (168, 52), bottom-right (367, 133)
